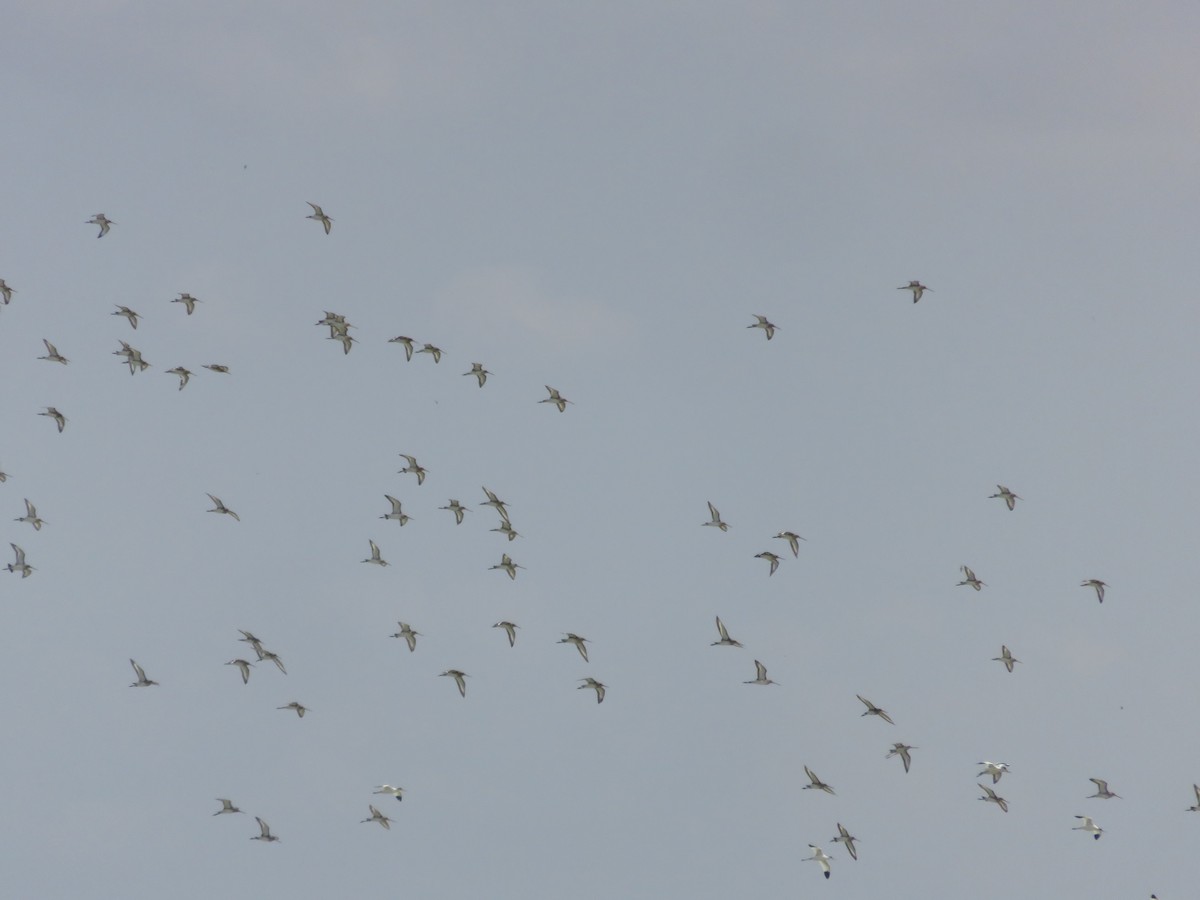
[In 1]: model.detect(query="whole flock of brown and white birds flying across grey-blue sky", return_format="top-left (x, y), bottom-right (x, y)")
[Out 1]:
top-left (0, 203), bottom-right (1180, 892)
